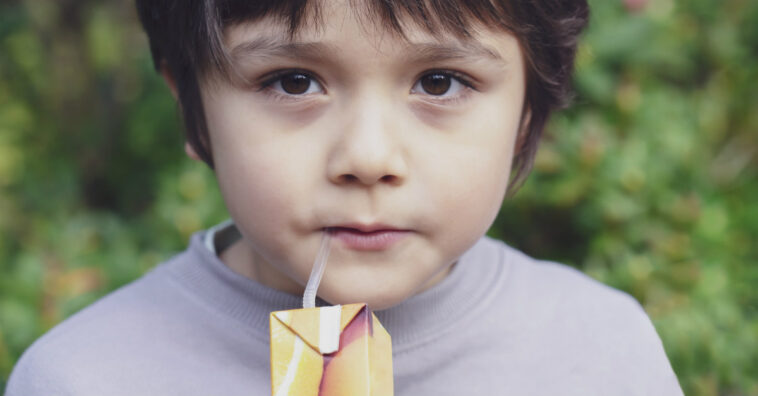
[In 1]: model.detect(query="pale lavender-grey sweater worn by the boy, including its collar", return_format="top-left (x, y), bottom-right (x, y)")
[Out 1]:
top-left (6, 227), bottom-right (682, 396)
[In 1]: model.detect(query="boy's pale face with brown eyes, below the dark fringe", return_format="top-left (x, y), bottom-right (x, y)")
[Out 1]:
top-left (197, 2), bottom-right (525, 309)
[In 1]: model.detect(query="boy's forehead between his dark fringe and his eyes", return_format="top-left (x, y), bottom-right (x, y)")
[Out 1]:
top-left (224, 0), bottom-right (519, 63)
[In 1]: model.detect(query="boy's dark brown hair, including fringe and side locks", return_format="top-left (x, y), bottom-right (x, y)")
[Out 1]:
top-left (136, 0), bottom-right (589, 187)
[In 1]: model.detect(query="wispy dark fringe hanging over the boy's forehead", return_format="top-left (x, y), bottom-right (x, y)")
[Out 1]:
top-left (203, 0), bottom-right (511, 77)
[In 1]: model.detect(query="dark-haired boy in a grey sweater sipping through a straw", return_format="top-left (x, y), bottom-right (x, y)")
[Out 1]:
top-left (8, 0), bottom-right (681, 396)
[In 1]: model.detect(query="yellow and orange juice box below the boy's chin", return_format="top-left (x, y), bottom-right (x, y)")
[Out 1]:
top-left (270, 304), bottom-right (393, 396)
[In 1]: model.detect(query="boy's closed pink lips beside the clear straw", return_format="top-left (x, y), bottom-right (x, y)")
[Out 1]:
top-left (324, 224), bottom-right (411, 251)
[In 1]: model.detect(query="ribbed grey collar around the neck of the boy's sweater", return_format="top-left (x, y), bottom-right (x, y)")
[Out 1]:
top-left (164, 231), bottom-right (507, 353)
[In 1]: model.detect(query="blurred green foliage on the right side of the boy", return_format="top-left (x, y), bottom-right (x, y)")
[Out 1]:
top-left (492, 1), bottom-right (758, 395)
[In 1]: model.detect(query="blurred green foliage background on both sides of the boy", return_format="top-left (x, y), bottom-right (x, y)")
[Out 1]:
top-left (0, 0), bottom-right (758, 395)
